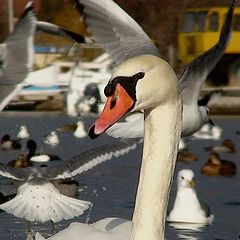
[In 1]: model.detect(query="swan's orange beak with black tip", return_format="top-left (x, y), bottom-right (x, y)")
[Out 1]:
top-left (88, 83), bottom-right (135, 139)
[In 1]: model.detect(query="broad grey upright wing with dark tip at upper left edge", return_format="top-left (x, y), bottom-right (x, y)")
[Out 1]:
top-left (0, 2), bottom-right (36, 110)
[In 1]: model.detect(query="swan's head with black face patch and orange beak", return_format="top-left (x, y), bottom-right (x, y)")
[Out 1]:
top-left (89, 55), bottom-right (178, 138)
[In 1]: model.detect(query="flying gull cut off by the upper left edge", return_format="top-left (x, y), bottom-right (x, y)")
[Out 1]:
top-left (0, 1), bottom-right (85, 111)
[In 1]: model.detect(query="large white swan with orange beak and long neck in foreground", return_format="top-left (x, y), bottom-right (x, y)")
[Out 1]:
top-left (36, 55), bottom-right (182, 240)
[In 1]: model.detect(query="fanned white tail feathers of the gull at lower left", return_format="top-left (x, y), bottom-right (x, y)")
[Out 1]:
top-left (0, 179), bottom-right (92, 223)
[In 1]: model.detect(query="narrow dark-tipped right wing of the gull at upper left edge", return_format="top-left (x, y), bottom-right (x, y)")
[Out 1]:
top-left (36, 21), bottom-right (85, 43)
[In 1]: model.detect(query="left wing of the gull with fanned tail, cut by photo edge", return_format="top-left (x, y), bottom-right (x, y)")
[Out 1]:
top-left (0, 163), bottom-right (30, 181)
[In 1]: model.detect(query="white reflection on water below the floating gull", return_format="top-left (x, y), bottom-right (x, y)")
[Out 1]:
top-left (168, 222), bottom-right (206, 240)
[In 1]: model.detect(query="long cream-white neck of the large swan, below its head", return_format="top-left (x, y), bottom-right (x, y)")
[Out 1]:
top-left (131, 102), bottom-right (182, 240)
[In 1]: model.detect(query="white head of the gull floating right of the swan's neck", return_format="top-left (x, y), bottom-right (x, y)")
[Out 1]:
top-left (178, 169), bottom-right (195, 188)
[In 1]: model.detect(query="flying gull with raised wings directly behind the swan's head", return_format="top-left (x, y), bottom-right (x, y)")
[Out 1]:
top-left (103, 0), bottom-right (235, 138)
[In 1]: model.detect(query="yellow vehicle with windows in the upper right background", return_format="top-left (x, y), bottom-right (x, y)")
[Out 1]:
top-left (178, 7), bottom-right (240, 85)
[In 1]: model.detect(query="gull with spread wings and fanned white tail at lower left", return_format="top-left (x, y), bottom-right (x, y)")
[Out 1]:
top-left (0, 141), bottom-right (139, 229)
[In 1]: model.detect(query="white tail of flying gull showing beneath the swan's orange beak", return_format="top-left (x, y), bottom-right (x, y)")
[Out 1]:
top-left (106, 112), bottom-right (144, 138)
